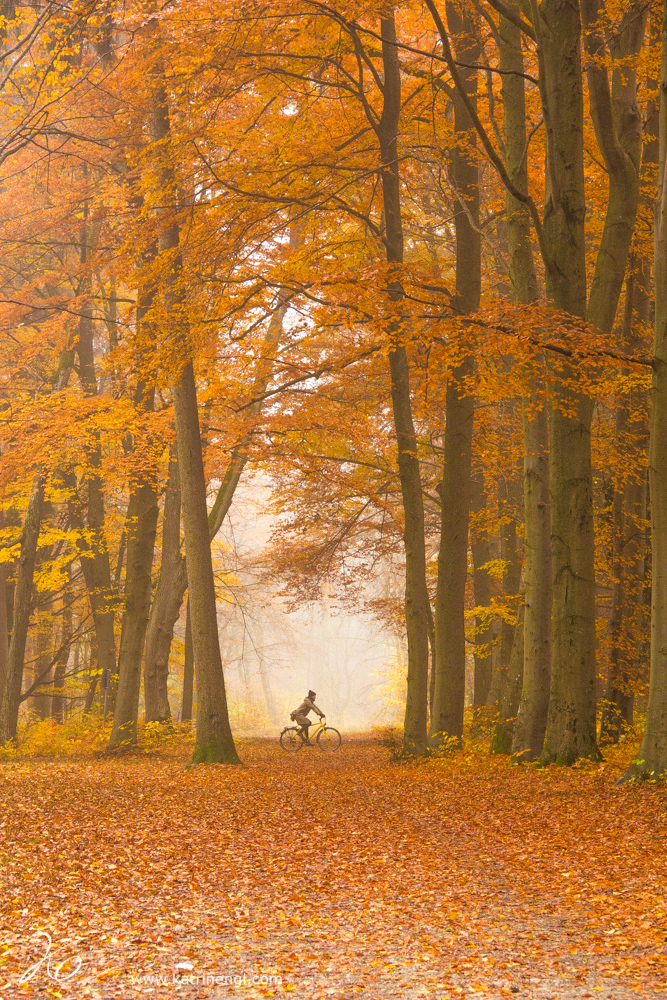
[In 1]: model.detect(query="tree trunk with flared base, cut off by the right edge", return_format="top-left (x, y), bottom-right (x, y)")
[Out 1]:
top-left (623, 0), bottom-right (667, 780)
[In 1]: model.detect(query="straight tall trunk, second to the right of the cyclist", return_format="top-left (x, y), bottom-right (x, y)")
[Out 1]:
top-left (431, 2), bottom-right (482, 744)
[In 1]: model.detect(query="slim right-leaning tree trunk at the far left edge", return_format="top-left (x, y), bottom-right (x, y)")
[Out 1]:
top-left (0, 472), bottom-right (46, 744)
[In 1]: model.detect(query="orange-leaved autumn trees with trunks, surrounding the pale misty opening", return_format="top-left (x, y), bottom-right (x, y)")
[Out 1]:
top-left (0, 0), bottom-right (667, 778)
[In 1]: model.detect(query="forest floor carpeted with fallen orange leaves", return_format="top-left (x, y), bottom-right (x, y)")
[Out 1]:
top-left (0, 738), bottom-right (667, 1000)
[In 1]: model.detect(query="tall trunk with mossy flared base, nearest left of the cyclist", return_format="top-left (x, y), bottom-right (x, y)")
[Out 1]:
top-left (150, 33), bottom-right (239, 764)
